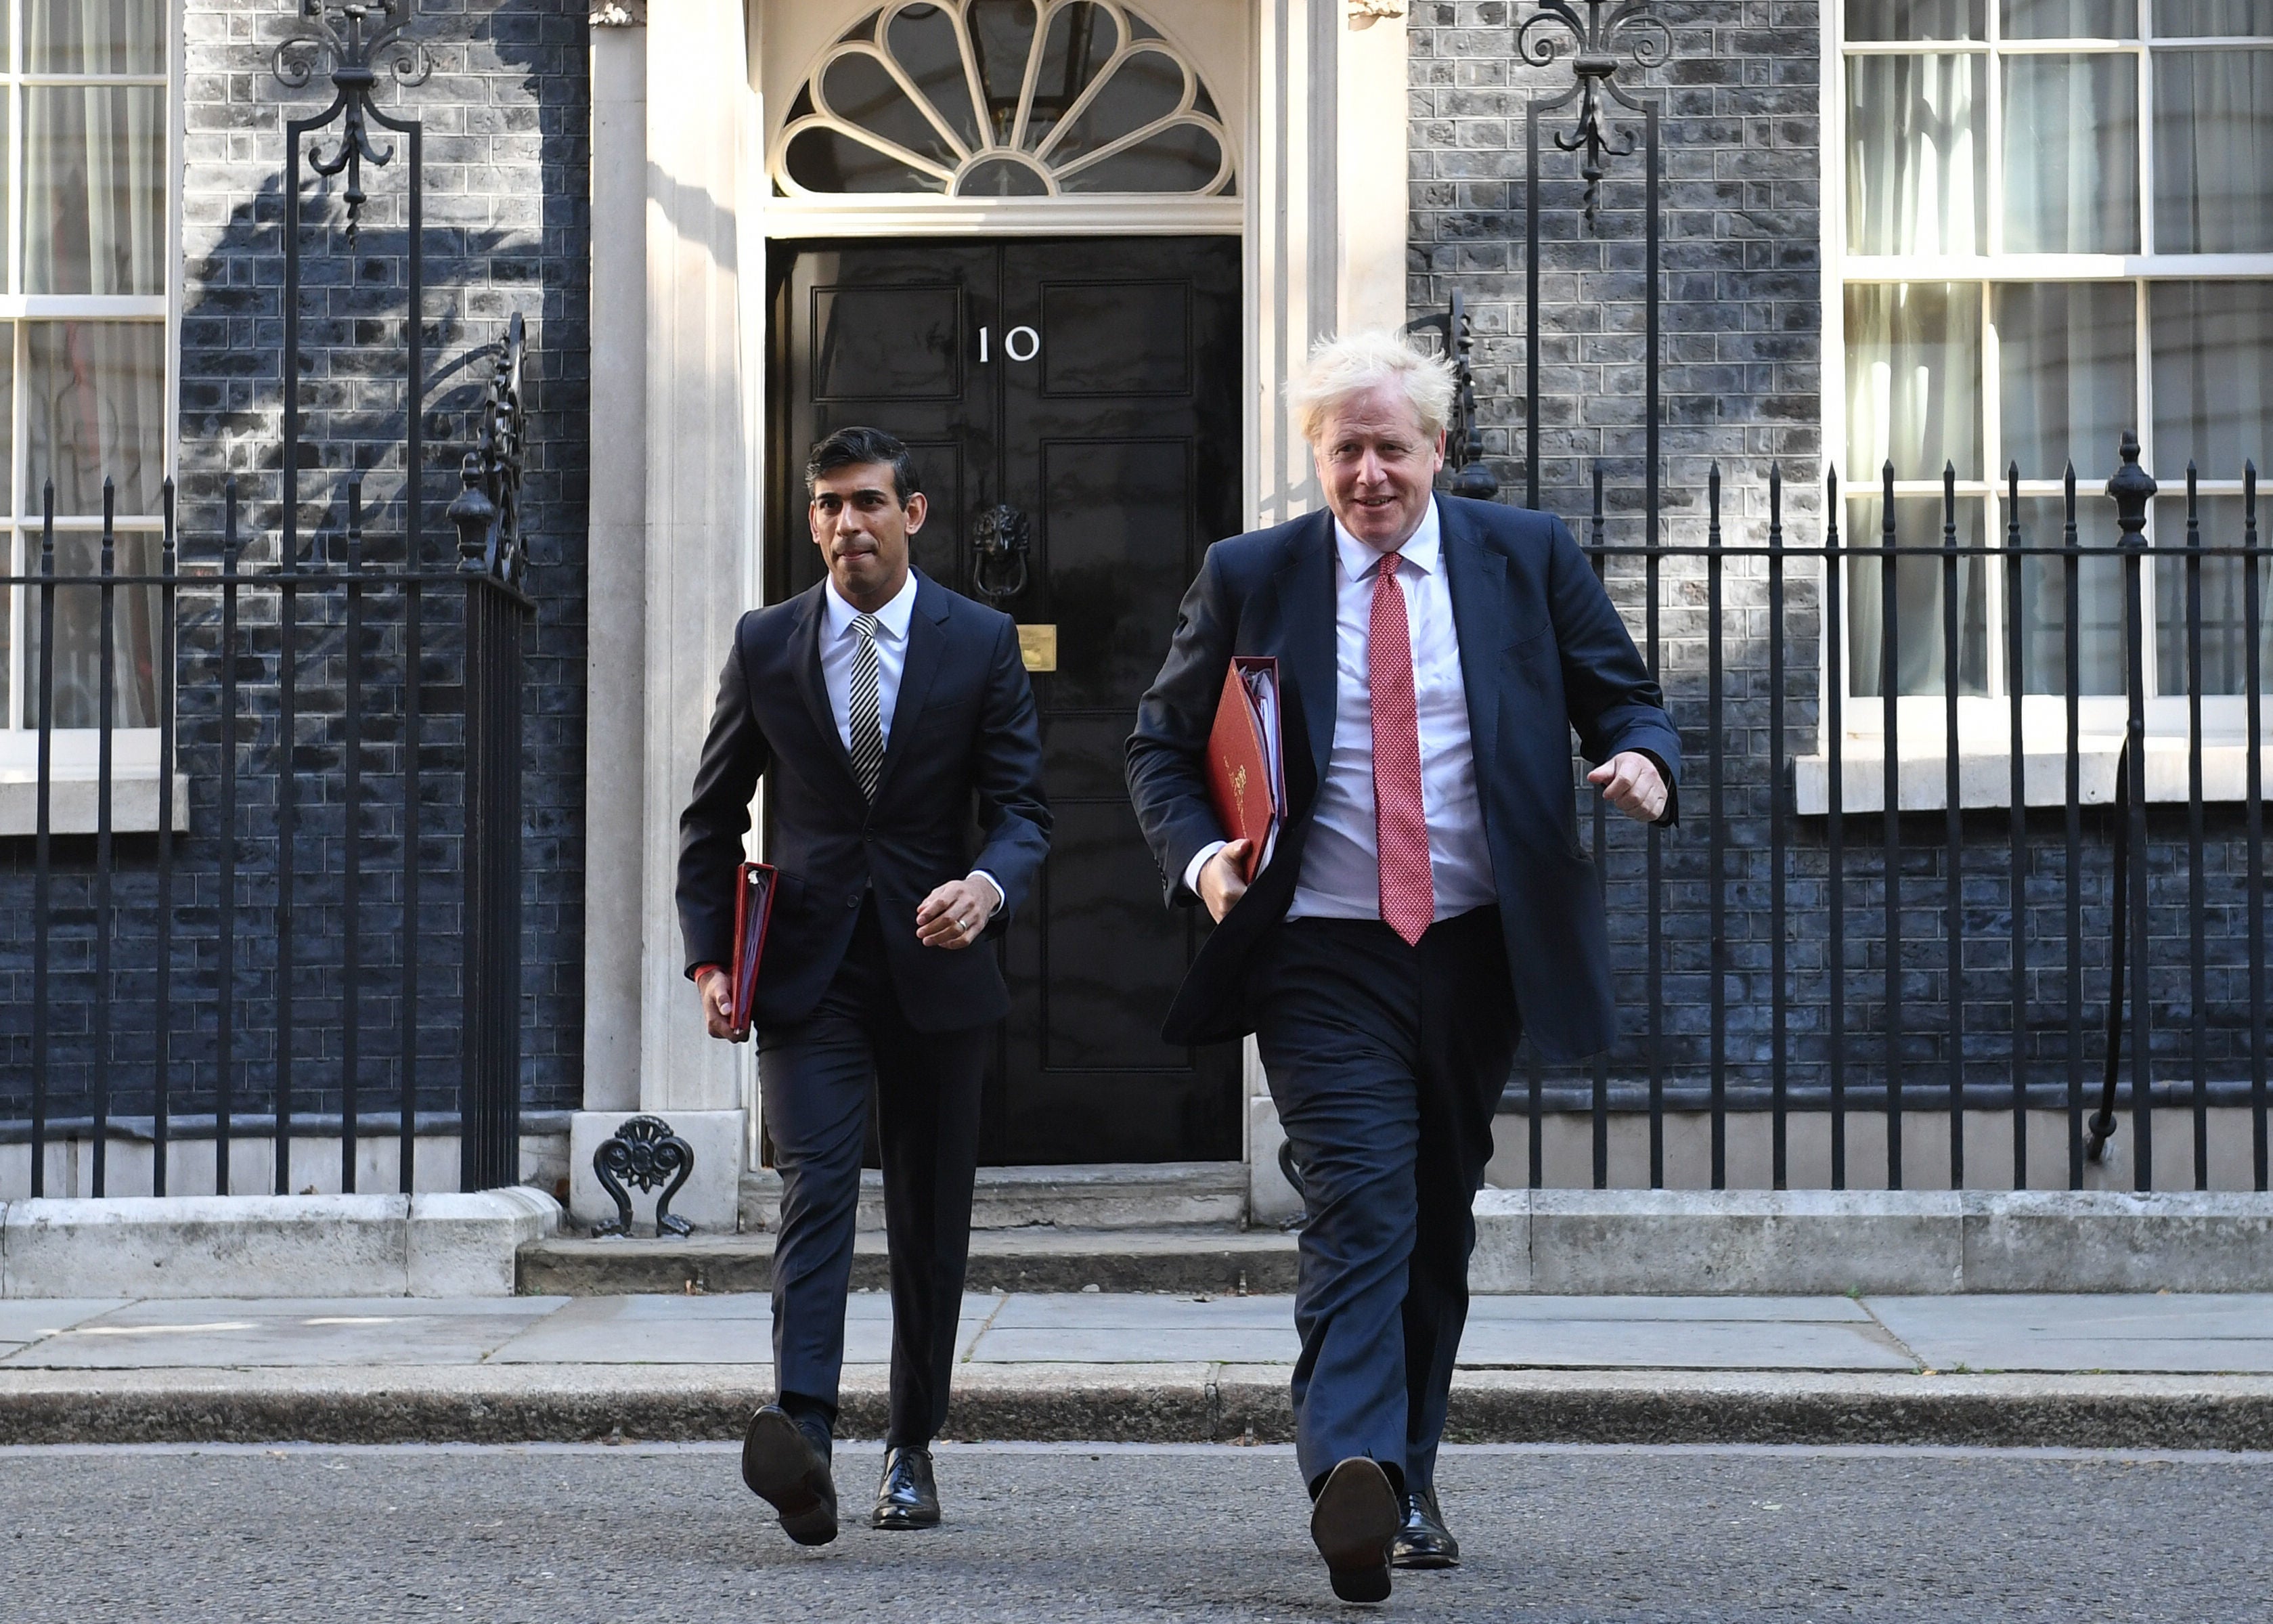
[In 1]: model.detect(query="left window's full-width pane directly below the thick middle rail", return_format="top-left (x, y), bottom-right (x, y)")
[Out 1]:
top-left (23, 321), bottom-right (166, 517)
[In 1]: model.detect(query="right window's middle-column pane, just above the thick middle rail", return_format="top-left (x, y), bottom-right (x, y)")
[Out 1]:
top-left (2005, 55), bottom-right (2139, 255)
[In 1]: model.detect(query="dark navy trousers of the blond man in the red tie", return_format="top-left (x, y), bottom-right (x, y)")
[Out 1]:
top-left (1250, 908), bottom-right (1521, 1492)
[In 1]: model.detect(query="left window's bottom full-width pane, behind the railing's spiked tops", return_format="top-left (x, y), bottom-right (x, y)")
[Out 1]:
top-left (23, 530), bottom-right (159, 728)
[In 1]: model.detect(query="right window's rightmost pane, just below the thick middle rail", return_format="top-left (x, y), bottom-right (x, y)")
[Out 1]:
top-left (2148, 282), bottom-right (2273, 485)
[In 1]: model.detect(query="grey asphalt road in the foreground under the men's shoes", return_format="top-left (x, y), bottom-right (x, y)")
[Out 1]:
top-left (0, 1445), bottom-right (2273, 1624)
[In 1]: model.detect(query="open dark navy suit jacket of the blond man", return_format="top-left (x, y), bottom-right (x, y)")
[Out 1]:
top-left (1128, 496), bottom-right (1682, 1060)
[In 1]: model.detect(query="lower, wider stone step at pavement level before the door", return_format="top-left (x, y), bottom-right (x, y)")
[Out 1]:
top-left (518, 1226), bottom-right (1296, 1296)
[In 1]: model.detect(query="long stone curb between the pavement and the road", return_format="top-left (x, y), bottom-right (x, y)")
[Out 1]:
top-left (0, 1365), bottom-right (2273, 1449)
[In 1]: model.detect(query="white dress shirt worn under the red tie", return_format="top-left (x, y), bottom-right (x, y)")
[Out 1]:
top-left (1185, 500), bottom-right (1500, 919)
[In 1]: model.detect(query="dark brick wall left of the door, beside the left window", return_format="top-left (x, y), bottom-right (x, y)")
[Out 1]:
top-left (0, 0), bottom-right (591, 1137)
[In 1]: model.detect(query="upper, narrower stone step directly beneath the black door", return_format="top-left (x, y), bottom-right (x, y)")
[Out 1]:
top-left (741, 1162), bottom-right (1248, 1233)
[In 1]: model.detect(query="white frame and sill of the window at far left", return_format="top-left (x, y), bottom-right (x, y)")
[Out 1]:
top-left (0, 0), bottom-right (189, 835)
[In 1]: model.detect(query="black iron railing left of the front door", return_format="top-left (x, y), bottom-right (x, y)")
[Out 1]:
top-left (0, 452), bottom-right (529, 1196)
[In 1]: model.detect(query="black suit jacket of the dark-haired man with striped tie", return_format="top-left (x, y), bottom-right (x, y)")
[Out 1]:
top-left (678, 571), bottom-right (1050, 1032)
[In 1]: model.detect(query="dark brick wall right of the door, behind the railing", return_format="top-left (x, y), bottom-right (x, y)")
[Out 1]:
top-left (1407, 0), bottom-right (2248, 1103)
